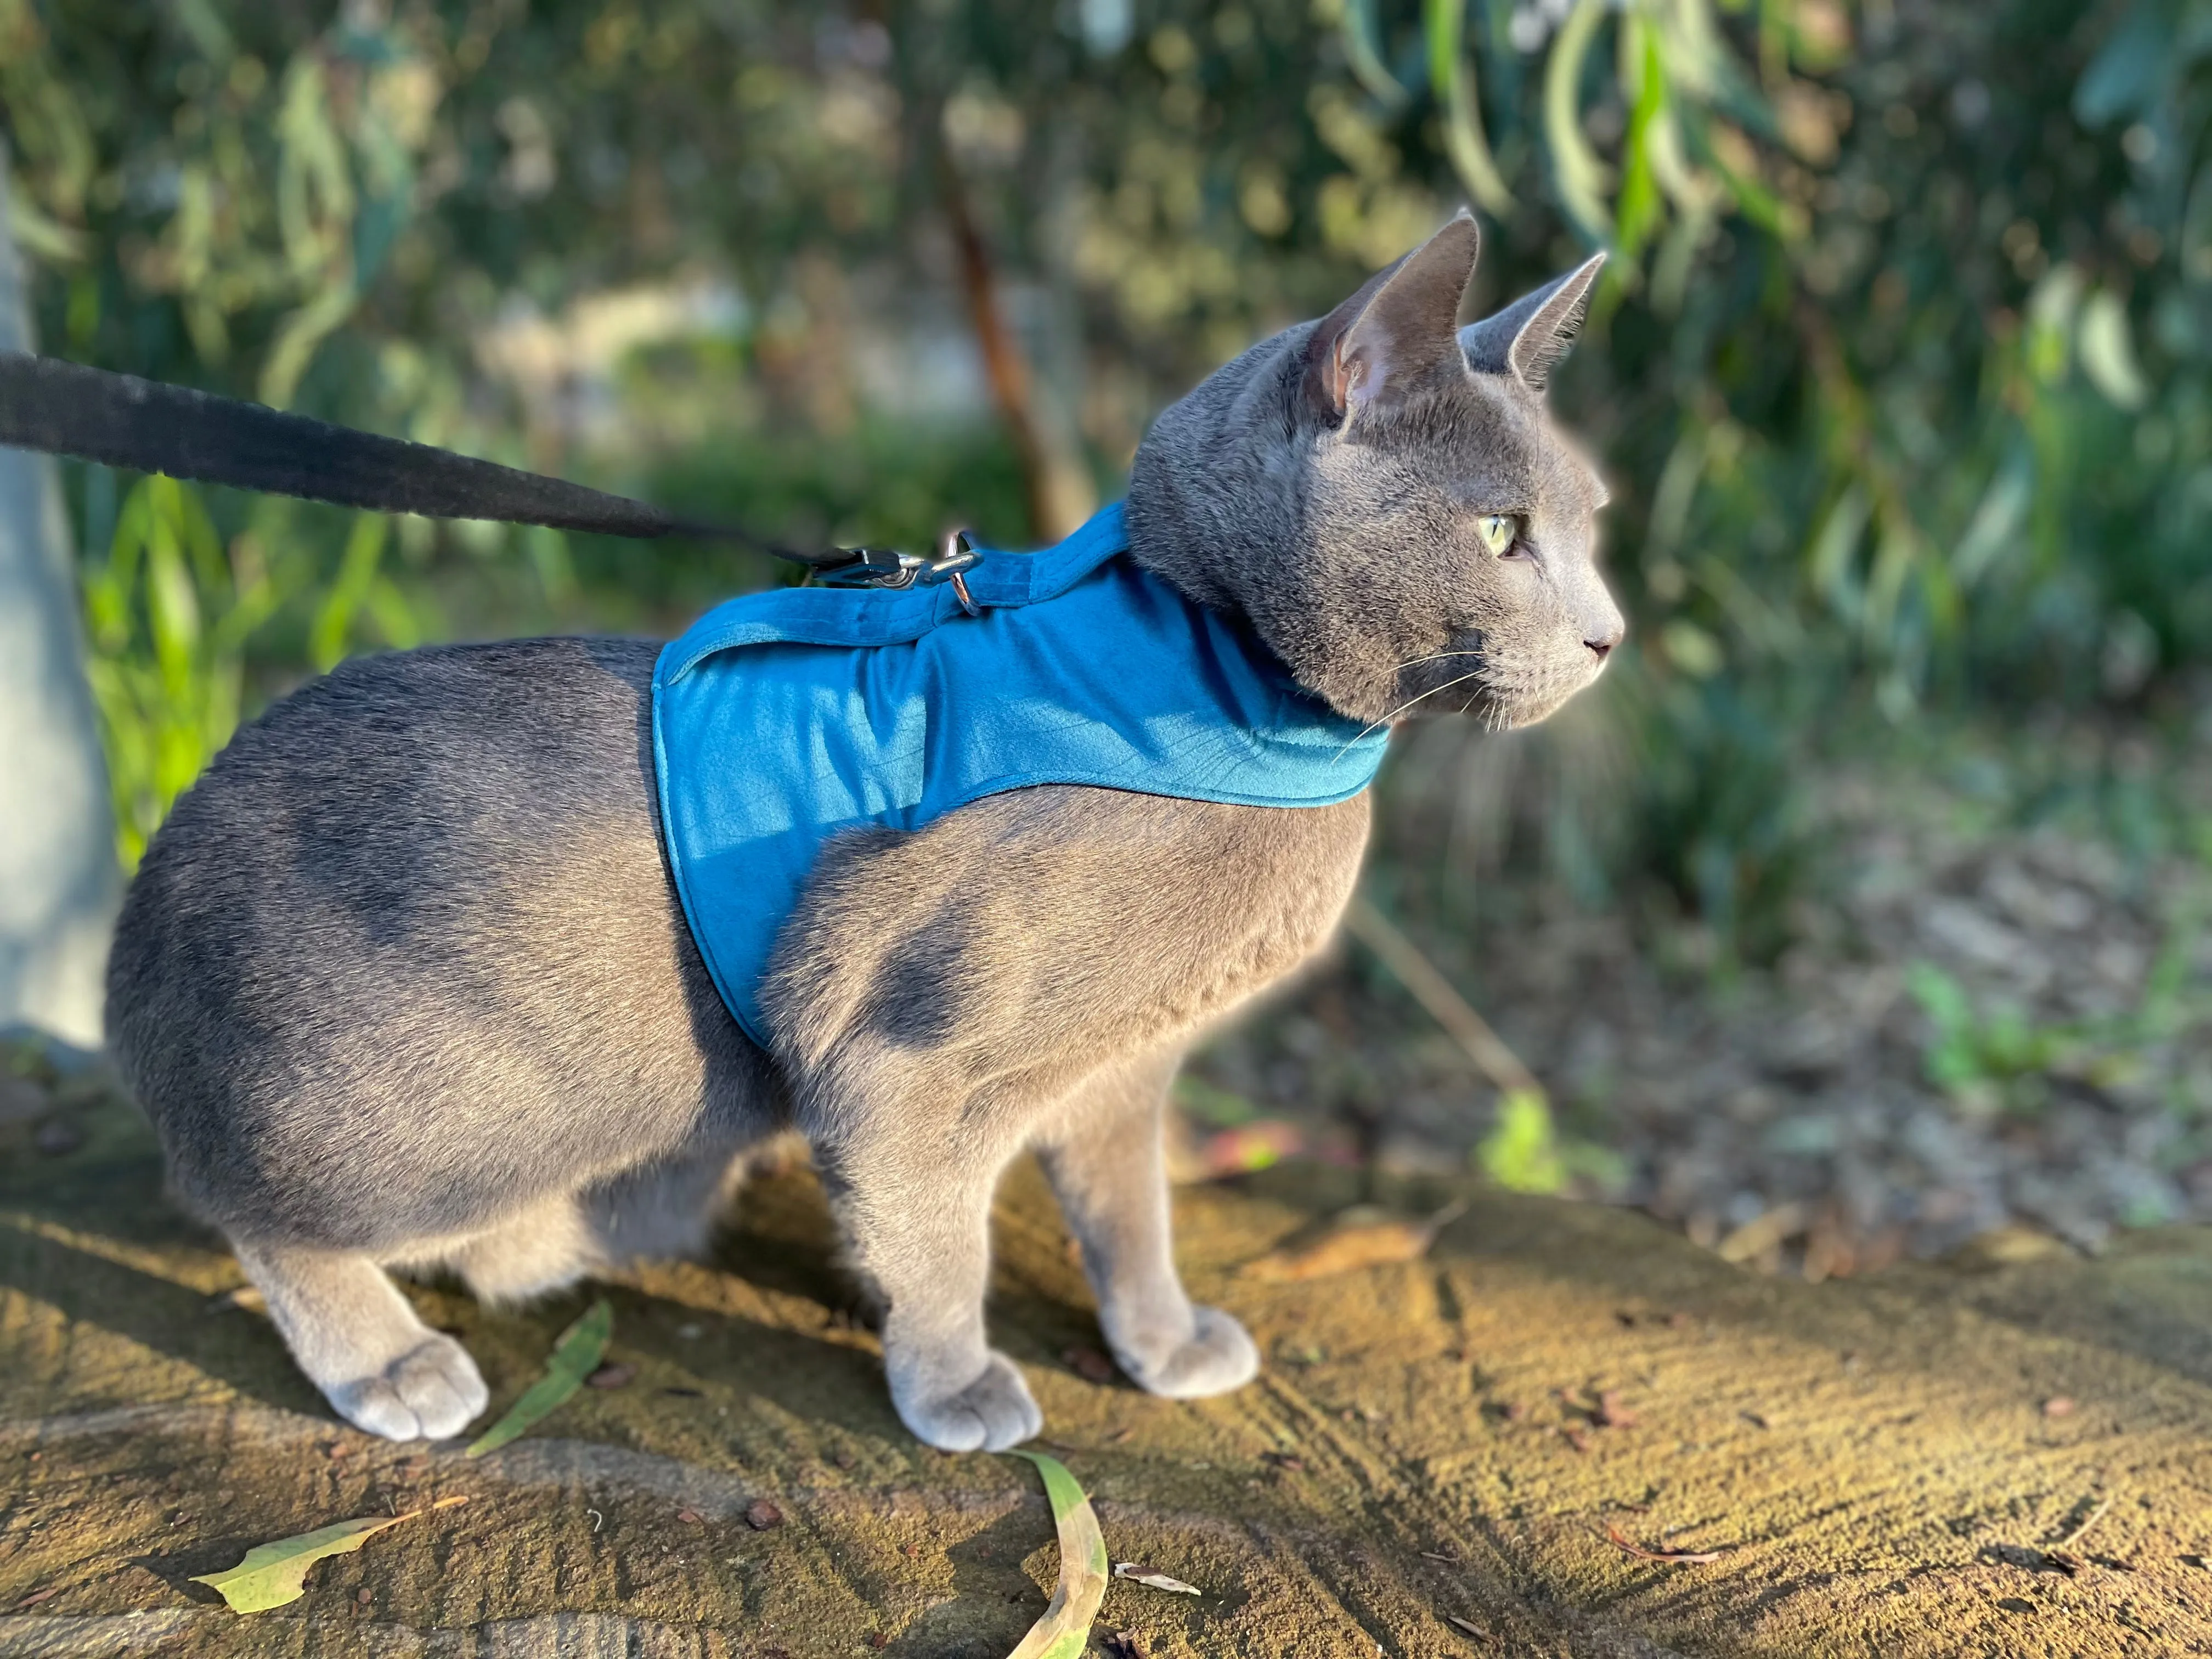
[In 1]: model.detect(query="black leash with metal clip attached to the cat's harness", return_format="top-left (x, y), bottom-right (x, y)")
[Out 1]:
top-left (0, 352), bottom-right (982, 608)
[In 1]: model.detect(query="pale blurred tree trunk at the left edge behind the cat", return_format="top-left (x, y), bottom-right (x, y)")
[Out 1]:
top-left (0, 150), bottom-right (120, 1048)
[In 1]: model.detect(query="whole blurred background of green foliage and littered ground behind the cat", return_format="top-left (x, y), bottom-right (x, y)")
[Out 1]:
top-left (0, 0), bottom-right (2212, 1276)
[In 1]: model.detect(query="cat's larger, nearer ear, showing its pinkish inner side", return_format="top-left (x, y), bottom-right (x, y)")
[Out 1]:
top-left (1305, 208), bottom-right (1482, 420)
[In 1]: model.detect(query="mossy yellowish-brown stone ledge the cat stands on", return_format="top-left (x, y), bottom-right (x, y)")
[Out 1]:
top-left (0, 1091), bottom-right (2212, 1659)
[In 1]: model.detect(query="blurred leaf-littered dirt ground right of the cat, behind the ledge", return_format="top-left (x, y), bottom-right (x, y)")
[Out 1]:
top-left (1194, 716), bottom-right (2212, 1276)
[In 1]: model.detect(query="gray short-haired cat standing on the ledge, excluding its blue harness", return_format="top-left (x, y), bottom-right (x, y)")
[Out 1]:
top-left (109, 215), bottom-right (1621, 1451)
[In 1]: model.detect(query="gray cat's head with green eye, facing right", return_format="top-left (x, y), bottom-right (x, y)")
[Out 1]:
top-left (1128, 212), bottom-right (1621, 725)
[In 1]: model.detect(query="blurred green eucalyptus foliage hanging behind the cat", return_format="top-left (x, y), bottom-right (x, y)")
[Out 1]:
top-left (0, 0), bottom-right (2212, 931)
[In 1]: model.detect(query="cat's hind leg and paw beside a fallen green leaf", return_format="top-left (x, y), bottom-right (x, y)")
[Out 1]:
top-left (236, 1245), bottom-right (491, 1440)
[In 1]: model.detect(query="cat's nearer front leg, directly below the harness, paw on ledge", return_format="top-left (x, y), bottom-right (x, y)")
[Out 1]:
top-left (814, 1108), bottom-right (1044, 1451)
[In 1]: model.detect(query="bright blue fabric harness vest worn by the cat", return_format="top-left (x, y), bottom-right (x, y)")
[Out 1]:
top-left (652, 504), bottom-right (1389, 1044)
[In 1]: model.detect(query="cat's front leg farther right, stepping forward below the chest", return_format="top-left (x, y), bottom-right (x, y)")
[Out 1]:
top-left (1037, 1053), bottom-right (1259, 1400)
